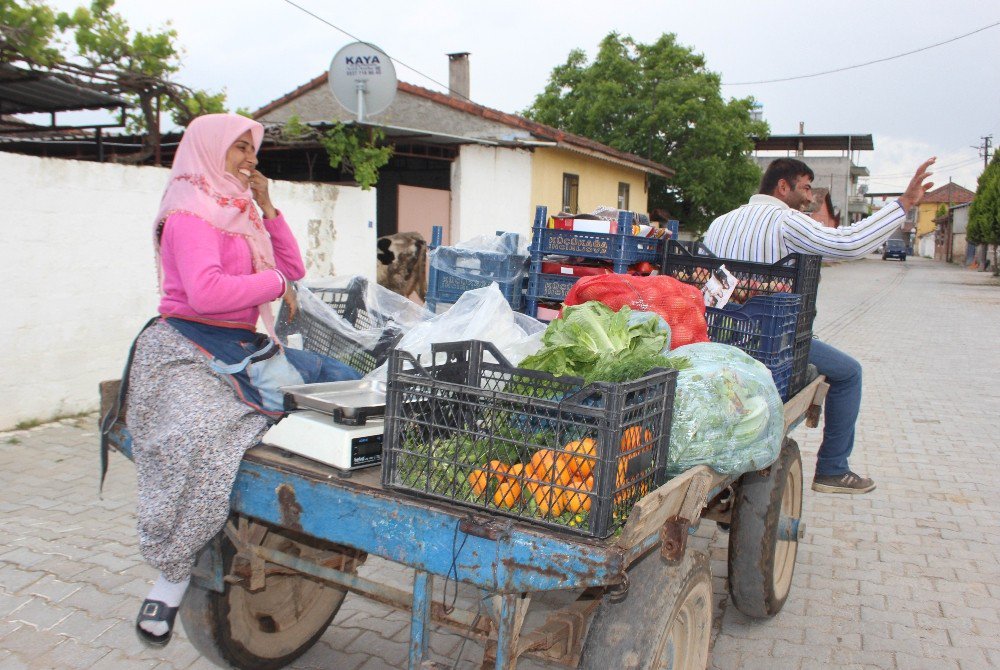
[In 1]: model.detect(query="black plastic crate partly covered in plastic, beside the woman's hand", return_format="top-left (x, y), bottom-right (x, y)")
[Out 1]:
top-left (274, 277), bottom-right (403, 374)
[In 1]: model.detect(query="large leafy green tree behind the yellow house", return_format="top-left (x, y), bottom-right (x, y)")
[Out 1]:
top-left (524, 32), bottom-right (768, 231)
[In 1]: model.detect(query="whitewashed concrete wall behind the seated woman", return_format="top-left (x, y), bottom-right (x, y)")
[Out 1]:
top-left (0, 152), bottom-right (375, 430)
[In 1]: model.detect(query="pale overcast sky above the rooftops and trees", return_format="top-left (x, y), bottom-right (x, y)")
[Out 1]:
top-left (41, 0), bottom-right (1000, 192)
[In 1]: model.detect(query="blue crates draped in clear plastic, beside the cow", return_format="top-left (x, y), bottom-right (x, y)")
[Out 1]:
top-left (424, 226), bottom-right (528, 312)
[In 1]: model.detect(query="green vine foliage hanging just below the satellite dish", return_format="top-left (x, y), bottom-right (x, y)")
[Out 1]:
top-left (281, 116), bottom-right (392, 191)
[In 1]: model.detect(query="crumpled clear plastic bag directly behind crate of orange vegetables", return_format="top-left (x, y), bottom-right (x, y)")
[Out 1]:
top-left (368, 284), bottom-right (545, 380)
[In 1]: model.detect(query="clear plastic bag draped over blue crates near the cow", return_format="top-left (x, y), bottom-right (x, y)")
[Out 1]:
top-left (429, 233), bottom-right (529, 285)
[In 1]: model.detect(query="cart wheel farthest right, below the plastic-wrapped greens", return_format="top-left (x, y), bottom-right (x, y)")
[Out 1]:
top-left (729, 437), bottom-right (805, 618)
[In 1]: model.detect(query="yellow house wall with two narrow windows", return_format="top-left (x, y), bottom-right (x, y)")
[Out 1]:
top-left (531, 148), bottom-right (648, 217)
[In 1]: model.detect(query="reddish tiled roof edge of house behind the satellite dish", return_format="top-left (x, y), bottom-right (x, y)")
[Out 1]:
top-left (253, 72), bottom-right (674, 177)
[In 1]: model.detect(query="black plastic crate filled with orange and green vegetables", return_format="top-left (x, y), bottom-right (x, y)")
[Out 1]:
top-left (382, 341), bottom-right (677, 538)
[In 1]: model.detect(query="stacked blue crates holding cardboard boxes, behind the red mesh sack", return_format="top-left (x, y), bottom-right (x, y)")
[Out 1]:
top-left (524, 205), bottom-right (664, 320)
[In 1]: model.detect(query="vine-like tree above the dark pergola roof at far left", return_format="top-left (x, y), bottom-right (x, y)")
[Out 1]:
top-left (0, 0), bottom-right (226, 162)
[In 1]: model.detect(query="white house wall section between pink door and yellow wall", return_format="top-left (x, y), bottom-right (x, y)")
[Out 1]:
top-left (451, 145), bottom-right (532, 243)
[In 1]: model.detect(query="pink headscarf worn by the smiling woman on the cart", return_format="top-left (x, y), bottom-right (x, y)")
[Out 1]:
top-left (153, 114), bottom-right (275, 337)
